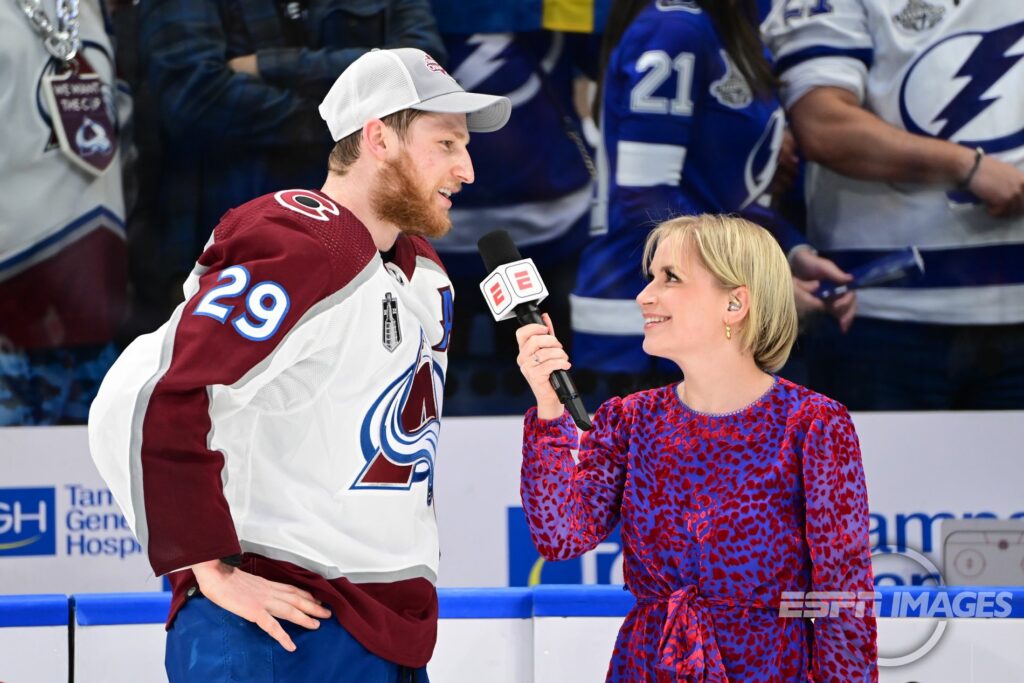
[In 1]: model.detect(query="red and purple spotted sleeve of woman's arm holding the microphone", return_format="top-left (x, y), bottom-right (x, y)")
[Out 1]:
top-left (520, 398), bottom-right (629, 560)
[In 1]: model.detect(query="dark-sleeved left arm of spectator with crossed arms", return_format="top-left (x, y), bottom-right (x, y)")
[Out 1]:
top-left (139, 0), bottom-right (331, 148)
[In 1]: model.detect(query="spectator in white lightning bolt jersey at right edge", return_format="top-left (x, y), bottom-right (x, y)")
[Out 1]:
top-left (764, 0), bottom-right (1024, 411)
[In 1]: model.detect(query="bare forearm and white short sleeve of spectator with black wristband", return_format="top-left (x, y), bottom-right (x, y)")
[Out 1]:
top-left (762, 0), bottom-right (1024, 216)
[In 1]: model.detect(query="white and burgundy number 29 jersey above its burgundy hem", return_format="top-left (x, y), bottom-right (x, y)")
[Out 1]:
top-left (89, 190), bottom-right (453, 583)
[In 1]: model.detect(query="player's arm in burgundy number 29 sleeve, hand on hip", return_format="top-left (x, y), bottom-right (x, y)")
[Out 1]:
top-left (131, 203), bottom-right (357, 650)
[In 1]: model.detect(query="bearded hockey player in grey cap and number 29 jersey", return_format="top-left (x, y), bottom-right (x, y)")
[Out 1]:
top-left (89, 48), bottom-right (510, 683)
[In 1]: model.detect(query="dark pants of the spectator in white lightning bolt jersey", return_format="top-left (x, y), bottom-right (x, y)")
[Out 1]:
top-left (802, 316), bottom-right (1024, 411)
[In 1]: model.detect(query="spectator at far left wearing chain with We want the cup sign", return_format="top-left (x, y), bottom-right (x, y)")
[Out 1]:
top-left (0, 0), bottom-right (131, 426)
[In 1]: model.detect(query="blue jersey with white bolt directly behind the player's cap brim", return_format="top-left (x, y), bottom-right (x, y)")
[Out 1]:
top-left (434, 31), bottom-right (594, 276)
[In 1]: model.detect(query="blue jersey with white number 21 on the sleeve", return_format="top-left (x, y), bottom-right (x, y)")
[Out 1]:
top-left (572, 0), bottom-right (784, 372)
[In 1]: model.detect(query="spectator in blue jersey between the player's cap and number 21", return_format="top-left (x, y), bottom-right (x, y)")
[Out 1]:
top-left (425, 14), bottom-right (597, 415)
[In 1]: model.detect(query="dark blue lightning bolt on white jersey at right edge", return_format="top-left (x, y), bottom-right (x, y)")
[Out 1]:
top-left (932, 22), bottom-right (1024, 140)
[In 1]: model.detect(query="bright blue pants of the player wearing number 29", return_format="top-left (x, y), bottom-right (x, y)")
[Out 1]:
top-left (164, 596), bottom-right (428, 683)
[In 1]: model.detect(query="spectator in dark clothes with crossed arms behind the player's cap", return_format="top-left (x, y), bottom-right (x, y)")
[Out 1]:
top-left (131, 0), bottom-right (445, 332)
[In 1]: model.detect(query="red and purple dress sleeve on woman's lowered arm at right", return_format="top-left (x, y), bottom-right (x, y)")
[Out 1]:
top-left (803, 403), bottom-right (878, 683)
